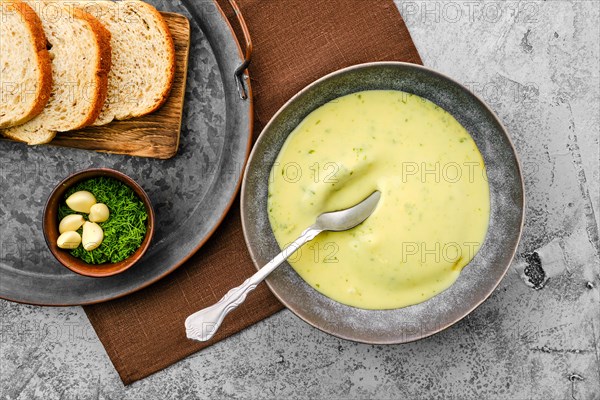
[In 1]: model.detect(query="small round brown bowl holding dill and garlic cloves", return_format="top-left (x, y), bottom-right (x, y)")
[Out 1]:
top-left (43, 168), bottom-right (154, 278)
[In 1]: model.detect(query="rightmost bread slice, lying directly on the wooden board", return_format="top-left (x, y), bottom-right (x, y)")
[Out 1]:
top-left (74, 0), bottom-right (175, 125)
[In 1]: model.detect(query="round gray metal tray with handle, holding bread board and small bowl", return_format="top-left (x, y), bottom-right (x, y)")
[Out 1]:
top-left (0, 0), bottom-right (253, 305)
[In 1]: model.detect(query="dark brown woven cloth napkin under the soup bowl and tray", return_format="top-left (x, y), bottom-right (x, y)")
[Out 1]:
top-left (85, 0), bottom-right (421, 385)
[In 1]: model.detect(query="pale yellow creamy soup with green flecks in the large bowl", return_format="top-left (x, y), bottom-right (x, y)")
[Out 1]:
top-left (268, 91), bottom-right (490, 309)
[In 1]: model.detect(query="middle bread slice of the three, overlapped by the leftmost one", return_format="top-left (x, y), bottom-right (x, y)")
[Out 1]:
top-left (3, 0), bottom-right (111, 144)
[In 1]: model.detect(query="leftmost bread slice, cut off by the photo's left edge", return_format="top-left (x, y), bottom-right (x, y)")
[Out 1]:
top-left (0, 0), bottom-right (52, 129)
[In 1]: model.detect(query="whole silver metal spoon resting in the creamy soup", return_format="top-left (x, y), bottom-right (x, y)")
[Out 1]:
top-left (185, 191), bottom-right (381, 342)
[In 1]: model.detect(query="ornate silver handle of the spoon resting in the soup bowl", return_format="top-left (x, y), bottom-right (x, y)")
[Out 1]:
top-left (185, 226), bottom-right (322, 342)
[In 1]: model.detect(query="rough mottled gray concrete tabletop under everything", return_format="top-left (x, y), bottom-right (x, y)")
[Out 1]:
top-left (0, 0), bottom-right (600, 399)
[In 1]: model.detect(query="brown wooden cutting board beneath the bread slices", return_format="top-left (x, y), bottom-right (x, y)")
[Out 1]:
top-left (3, 12), bottom-right (190, 159)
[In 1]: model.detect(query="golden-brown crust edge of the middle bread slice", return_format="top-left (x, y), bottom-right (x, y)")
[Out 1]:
top-left (73, 7), bottom-right (112, 130)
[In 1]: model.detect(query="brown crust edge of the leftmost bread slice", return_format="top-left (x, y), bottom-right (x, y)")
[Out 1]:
top-left (0, 0), bottom-right (52, 128)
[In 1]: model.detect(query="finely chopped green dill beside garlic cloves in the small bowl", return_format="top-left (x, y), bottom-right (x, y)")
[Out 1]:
top-left (58, 176), bottom-right (148, 264)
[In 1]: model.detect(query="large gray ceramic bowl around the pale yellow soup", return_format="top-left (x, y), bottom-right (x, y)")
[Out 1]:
top-left (241, 62), bottom-right (524, 344)
